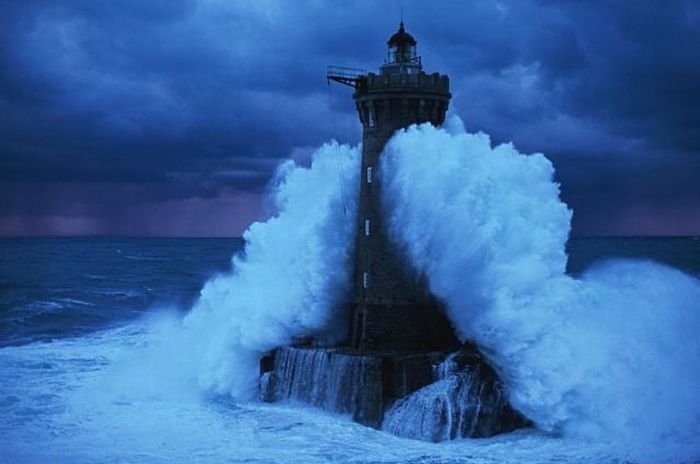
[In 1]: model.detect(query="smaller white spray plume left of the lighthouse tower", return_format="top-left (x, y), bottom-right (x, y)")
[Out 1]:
top-left (183, 142), bottom-right (359, 399)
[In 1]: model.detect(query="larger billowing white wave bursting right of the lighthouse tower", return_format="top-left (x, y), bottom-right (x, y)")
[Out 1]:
top-left (381, 119), bottom-right (700, 447)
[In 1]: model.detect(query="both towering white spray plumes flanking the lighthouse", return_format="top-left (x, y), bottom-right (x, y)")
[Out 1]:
top-left (115, 118), bottom-right (700, 455)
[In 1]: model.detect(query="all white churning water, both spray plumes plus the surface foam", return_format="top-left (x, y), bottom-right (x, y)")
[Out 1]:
top-left (0, 119), bottom-right (700, 463)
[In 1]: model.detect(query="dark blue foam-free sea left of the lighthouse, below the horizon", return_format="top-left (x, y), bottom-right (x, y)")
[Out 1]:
top-left (0, 238), bottom-right (243, 346)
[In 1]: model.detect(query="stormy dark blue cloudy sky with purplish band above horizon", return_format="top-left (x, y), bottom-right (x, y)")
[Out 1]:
top-left (0, 0), bottom-right (700, 237)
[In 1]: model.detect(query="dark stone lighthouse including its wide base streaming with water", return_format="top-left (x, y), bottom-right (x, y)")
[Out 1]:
top-left (260, 22), bottom-right (527, 441)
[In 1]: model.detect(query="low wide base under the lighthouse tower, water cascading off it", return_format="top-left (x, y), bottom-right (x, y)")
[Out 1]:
top-left (260, 346), bottom-right (527, 442)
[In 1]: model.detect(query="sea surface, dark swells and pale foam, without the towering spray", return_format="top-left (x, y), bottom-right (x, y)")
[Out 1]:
top-left (0, 237), bottom-right (700, 464)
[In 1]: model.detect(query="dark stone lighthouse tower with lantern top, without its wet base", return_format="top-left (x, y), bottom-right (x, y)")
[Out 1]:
top-left (327, 22), bottom-right (456, 352)
